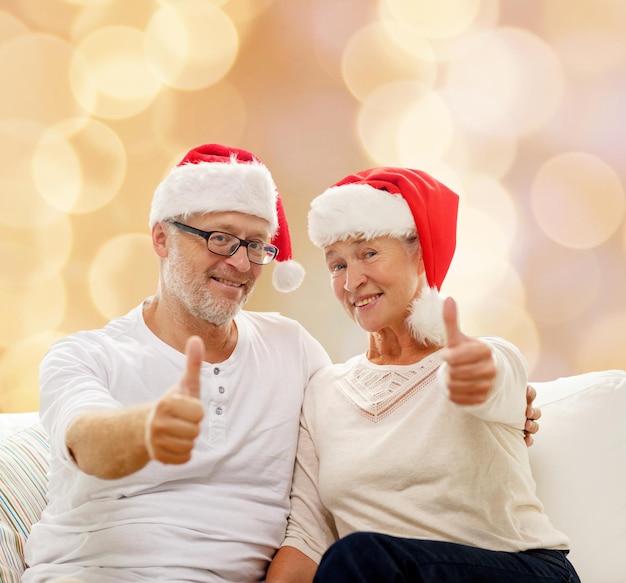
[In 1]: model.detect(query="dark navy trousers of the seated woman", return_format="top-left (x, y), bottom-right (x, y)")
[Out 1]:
top-left (314, 532), bottom-right (580, 583)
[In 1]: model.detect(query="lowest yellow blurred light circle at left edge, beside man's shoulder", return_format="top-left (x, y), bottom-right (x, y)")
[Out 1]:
top-left (0, 331), bottom-right (64, 413)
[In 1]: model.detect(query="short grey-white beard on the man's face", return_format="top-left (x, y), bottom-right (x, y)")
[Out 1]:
top-left (161, 245), bottom-right (254, 326)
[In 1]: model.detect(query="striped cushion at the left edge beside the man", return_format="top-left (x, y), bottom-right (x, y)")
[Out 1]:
top-left (0, 424), bottom-right (49, 583)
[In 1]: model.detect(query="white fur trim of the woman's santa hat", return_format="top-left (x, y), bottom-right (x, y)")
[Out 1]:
top-left (308, 184), bottom-right (416, 247)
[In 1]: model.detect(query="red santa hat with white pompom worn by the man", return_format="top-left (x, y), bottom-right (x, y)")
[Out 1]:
top-left (150, 144), bottom-right (304, 292)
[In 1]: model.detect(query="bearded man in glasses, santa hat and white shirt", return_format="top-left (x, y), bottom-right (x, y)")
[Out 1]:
top-left (23, 145), bottom-right (330, 583)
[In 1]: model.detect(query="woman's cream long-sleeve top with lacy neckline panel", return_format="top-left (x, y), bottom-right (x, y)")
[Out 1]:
top-left (283, 338), bottom-right (569, 562)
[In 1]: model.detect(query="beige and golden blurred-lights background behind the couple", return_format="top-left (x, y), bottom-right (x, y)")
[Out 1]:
top-left (0, 0), bottom-right (626, 411)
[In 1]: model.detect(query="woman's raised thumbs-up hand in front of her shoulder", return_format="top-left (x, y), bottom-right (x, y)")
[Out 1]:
top-left (442, 298), bottom-right (497, 405)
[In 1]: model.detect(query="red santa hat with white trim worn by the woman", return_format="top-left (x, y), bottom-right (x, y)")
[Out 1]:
top-left (308, 167), bottom-right (459, 345)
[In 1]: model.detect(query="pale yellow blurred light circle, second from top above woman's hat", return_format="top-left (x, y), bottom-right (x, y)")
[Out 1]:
top-left (341, 21), bottom-right (437, 101)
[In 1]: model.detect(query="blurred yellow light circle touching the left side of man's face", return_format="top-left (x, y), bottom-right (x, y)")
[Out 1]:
top-left (89, 233), bottom-right (158, 320)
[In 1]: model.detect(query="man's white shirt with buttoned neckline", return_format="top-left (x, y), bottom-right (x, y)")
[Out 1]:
top-left (23, 306), bottom-right (330, 583)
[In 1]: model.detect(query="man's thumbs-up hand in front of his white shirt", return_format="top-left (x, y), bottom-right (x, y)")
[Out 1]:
top-left (145, 336), bottom-right (204, 464)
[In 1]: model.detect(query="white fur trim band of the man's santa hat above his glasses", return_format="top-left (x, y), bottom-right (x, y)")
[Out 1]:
top-left (150, 156), bottom-right (278, 234)
